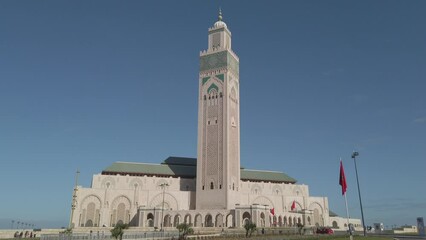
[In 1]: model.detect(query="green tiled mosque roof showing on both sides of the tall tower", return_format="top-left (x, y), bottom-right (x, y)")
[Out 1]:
top-left (102, 157), bottom-right (296, 183)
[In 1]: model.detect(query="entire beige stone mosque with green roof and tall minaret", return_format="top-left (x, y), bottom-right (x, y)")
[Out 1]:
top-left (70, 10), bottom-right (361, 229)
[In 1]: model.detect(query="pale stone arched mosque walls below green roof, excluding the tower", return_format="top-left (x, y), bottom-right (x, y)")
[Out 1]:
top-left (72, 171), bottom-right (330, 228)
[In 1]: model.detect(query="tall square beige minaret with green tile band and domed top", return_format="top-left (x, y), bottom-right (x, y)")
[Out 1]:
top-left (196, 10), bottom-right (240, 209)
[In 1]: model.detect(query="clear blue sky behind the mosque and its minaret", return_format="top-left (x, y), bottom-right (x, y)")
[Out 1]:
top-left (0, 0), bottom-right (426, 228)
